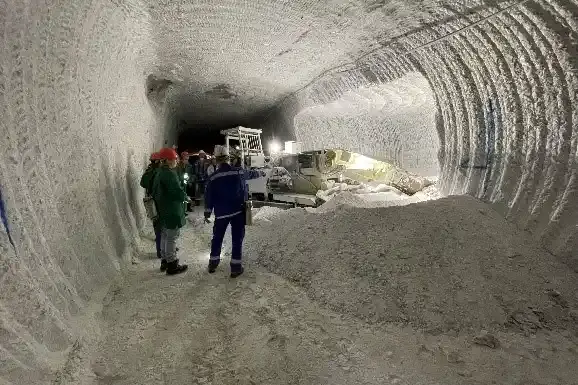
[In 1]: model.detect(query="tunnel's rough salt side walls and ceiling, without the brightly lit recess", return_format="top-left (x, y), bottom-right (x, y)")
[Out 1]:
top-left (0, 0), bottom-right (578, 383)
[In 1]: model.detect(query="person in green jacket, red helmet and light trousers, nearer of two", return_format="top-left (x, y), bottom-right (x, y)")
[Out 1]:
top-left (152, 148), bottom-right (187, 275)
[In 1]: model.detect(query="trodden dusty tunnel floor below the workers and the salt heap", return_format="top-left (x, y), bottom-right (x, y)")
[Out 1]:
top-left (86, 201), bottom-right (578, 385)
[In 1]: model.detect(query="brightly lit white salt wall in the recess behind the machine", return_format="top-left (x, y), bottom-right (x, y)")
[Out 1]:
top-left (295, 72), bottom-right (439, 176)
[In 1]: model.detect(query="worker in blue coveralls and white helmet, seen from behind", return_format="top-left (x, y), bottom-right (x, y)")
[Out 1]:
top-left (205, 145), bottom-right (265, 278)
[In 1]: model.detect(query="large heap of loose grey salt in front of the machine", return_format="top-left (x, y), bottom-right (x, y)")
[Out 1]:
top-left (245, 194), bottom-right (578, 332)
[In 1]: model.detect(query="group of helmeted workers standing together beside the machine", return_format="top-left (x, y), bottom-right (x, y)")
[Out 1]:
top-left (140, 145), bottom-right (264, 278)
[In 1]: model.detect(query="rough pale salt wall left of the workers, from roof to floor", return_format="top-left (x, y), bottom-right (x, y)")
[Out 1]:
top-left (0, 0), bottom-right (159, 384)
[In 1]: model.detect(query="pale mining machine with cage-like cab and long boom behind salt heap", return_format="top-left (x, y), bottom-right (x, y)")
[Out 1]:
top-left (221, 126), bottom-right (427, 207)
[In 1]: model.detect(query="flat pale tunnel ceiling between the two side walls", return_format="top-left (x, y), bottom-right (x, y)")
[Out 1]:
top-left (149, 0), bottom-right (488, 125)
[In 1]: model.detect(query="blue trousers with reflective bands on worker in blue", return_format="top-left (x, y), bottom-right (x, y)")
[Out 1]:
top-left (209, 212), bottom-right (245, 272)
